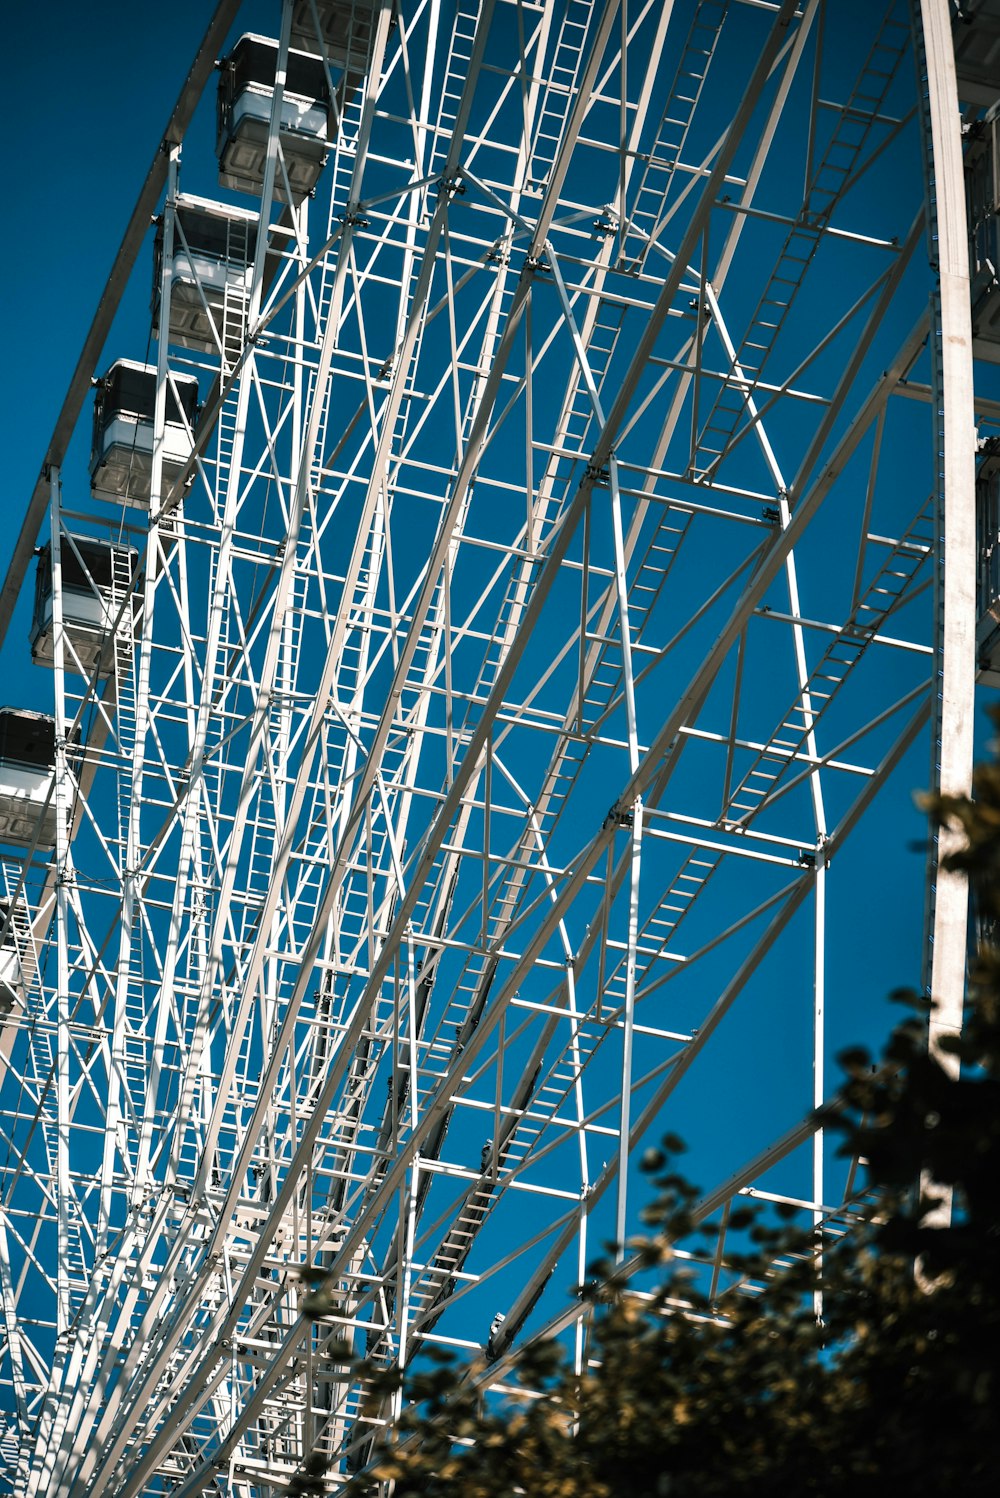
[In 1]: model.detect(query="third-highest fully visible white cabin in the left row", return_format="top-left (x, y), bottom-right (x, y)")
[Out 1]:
top-left (90, 360), bottom-right (198, 508)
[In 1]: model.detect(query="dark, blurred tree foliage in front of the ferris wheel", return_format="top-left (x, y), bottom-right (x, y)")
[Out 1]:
top-left (320, 749), bottom-right (1000, 1498)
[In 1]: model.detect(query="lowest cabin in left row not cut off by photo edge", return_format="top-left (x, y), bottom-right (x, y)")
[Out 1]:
top-left (30, 536), bottom-right (139, 676)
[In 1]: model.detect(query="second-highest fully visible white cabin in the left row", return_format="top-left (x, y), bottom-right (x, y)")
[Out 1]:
top-left (153, 198), bottom-right (259, 354)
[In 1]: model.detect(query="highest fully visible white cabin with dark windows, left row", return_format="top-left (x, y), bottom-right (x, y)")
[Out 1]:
top-left (217, 33), bottom-right (331, 202)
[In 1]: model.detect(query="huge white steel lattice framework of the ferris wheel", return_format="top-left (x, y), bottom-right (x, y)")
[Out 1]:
top-left (0, 0), bottom-right (982, 1498)
